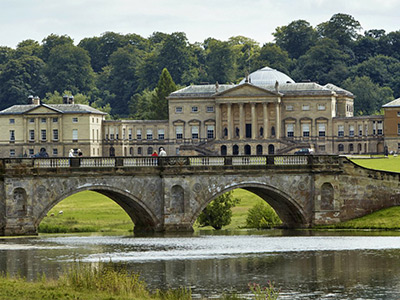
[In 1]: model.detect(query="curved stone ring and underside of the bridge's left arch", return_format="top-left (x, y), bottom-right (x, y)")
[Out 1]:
top-left (34, 185), bottom-right (162, 232)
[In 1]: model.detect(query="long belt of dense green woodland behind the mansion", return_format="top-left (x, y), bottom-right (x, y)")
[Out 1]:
top-left (0, 13), bottom-right (400, 119)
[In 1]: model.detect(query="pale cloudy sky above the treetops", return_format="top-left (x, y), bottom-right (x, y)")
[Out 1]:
top-left (0, 0), bottom-right (400, 48)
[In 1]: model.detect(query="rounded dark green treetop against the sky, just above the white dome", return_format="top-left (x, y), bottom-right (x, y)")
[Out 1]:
top-left (272, 20), bottom-right (318, 58)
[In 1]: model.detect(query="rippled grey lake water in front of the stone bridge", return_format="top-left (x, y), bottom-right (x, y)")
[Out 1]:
top-left (0, 232), bottom-right (400, 299)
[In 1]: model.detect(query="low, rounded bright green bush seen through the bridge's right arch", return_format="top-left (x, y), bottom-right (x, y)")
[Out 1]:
top-left (246, 201), bottom-right (282, 229)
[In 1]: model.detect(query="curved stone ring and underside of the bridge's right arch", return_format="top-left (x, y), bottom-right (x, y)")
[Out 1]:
top-left (191, 182), bottom-right (309, 228)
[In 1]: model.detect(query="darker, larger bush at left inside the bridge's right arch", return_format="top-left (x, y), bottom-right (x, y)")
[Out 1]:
top-left (197, 192), bottom-right (240, 230)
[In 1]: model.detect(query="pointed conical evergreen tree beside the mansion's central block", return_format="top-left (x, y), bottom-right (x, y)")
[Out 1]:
top-left (149, 68), bottom-right (176, 120)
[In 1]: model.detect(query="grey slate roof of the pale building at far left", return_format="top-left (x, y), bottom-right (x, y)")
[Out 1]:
top-left (0, 103), bottom-right (107, 115)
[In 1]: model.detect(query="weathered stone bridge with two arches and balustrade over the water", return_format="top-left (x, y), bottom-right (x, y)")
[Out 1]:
top-left (0, 155), bottom-right (400, 235)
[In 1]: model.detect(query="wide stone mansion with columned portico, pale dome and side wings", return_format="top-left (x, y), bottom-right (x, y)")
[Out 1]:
top-left (0, 67), bottom-right (400, 157)
